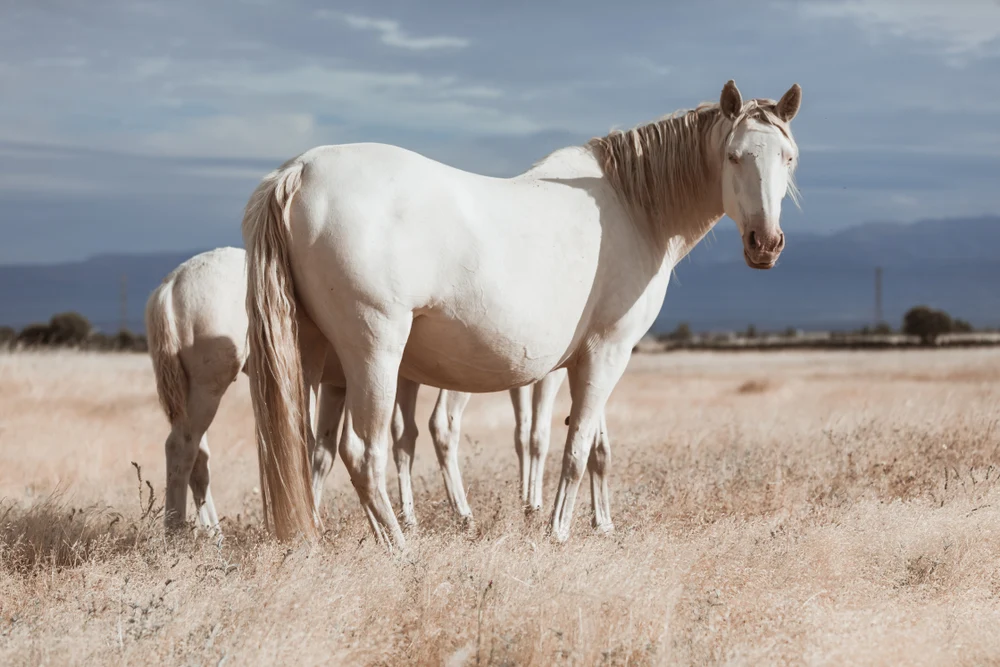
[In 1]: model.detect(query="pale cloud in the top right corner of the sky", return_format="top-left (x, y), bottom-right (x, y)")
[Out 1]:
top-left (797, 0), bottom-right (1000, 61)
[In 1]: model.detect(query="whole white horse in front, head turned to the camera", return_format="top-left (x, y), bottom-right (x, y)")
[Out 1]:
top-left (243, 81), bottom-right (801, 547)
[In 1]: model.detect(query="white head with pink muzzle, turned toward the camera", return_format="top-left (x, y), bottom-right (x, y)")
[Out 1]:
top-left (719, 80), bottom-right (802, 269)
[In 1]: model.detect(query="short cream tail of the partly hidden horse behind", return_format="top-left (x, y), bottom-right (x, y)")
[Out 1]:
top-left (145, 276), bottom-right (188, 425)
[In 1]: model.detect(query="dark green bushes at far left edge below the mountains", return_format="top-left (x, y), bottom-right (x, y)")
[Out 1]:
top-left (0, 313), bottom-right (146, 352)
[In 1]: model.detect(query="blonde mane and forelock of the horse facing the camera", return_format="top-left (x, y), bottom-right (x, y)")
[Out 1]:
top-left (587, 99), bottom-right (798, 247)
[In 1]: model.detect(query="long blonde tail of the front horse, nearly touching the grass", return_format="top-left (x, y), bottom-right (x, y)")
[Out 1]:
top-left (243, 159), bottom-right (319, 540)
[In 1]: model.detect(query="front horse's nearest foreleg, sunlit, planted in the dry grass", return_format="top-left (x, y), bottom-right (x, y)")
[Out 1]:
top-left (552, 346), bottom-right (631, 542)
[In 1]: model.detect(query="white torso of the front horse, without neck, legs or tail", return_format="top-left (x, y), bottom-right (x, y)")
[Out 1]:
top-left (290, 144), bottom-right (656, 392)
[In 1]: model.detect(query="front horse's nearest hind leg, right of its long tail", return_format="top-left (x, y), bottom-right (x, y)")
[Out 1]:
top-left (338, 314), bottom-right (413, 549)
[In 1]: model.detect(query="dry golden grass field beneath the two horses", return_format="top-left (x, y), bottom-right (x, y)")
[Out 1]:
top-left (0, 349), bottom-right (1000, 666)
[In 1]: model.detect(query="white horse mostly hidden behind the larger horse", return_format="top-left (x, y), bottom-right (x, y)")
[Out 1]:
top-left (146, 248), bottom-right (565, 530)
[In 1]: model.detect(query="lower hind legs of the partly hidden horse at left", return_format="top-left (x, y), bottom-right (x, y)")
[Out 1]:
top-left (164, 382), bottom-right (225, 530)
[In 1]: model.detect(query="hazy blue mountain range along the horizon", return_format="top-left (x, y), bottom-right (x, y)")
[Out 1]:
top-left (0, 216), bottom-right (1000, 332)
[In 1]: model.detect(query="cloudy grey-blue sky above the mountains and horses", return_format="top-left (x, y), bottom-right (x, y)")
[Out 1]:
top-left (0, 0), bottom-right (1000, 263)
